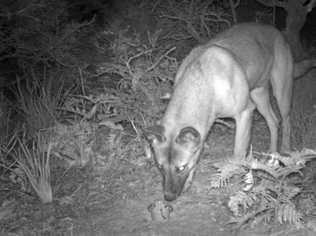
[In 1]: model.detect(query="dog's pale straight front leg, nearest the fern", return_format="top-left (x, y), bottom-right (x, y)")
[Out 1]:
top-left (234, 101), bottom-right (255, 158)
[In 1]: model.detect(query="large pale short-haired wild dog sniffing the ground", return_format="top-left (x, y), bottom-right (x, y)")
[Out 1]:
top-left (151, 23), bottom-right (312, 201)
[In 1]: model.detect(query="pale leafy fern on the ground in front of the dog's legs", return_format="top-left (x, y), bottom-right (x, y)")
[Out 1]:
top-left (211, 149), bottom-right (316, 228)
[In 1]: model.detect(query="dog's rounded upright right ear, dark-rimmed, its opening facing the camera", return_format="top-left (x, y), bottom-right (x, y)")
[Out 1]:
top-left (176, 126), bottom-right (201, 147)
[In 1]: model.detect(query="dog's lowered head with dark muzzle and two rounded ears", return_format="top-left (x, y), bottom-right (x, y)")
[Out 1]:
top-left (148, 126), bottom-right (203, 201)
